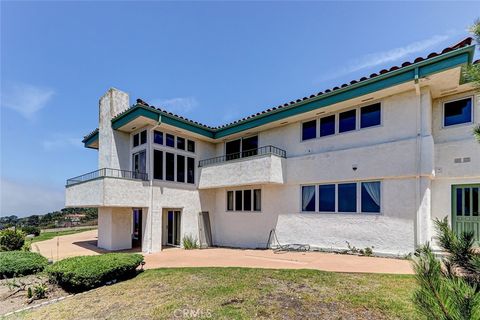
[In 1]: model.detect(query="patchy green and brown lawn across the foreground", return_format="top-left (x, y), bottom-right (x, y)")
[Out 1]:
top-left (9, 268), bottom-right (422, 320)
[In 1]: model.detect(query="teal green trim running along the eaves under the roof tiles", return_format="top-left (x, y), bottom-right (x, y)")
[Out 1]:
top-left (84, 45), bottom-right (475, 147)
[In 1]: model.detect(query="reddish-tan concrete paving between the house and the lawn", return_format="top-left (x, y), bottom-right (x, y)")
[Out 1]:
top-left (32, 230), bottom-right (413, 274)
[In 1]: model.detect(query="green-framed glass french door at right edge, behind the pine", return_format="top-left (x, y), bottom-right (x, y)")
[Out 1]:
top-left (452, 184), bottom-right (480, 245)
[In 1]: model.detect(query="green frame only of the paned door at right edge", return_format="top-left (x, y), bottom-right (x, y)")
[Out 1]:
top-left (451, 183), bottom-right (480, 245)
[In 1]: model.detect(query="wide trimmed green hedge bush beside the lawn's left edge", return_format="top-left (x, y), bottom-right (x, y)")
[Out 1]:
top-left (47, 253), bottom-right (143, 292)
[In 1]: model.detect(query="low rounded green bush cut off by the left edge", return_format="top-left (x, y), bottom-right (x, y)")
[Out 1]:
top-left (0, 251), bottom-right (48, 278)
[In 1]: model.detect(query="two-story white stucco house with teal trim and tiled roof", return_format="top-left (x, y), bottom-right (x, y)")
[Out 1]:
top-left (66, 38), bottom-right (480, 255)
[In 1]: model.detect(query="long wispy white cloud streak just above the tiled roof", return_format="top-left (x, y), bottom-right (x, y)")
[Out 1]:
top-left (318, 32), bottom-right (452, 82)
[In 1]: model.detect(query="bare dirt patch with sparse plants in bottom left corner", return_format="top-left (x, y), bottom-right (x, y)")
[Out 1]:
top-left (0, 275), bottom-right (69, 316)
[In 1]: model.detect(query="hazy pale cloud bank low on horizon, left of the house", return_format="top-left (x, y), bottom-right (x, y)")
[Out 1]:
top-left (0, 178), bottom-right (65, 217)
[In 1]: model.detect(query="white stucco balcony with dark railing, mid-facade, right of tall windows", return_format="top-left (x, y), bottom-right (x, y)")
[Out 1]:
top-left (198, 146), bottom-right (286, 189)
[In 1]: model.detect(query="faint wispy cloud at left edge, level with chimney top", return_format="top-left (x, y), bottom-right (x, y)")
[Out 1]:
top-left (0, 83), bottom-right (55, 120)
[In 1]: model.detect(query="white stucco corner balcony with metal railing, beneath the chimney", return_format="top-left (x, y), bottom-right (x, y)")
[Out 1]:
top-left (65, 168), bottom-right (149, 207)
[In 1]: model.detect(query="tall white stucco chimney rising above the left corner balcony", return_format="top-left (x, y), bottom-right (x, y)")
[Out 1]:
top-left (98, 88), bottom-right (130, 170)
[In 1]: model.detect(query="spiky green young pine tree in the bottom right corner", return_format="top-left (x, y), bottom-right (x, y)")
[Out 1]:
top-left (413, 218), bottom-right (480, 320)
